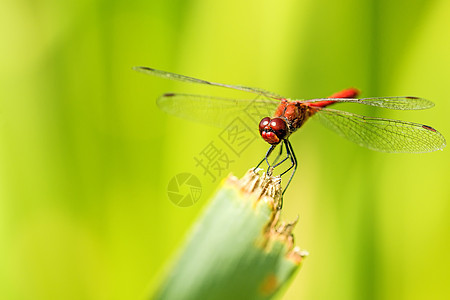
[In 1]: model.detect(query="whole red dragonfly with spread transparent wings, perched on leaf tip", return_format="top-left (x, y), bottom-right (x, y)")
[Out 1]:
top-left (133, 67), bottom-right (446, 199)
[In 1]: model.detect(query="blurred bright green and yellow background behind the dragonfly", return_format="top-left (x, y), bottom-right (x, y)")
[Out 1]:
top-left (0, 0), bottom-right (450, 299)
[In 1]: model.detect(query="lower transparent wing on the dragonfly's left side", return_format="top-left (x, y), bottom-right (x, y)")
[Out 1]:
top-left (156, 93), bottom-right (279, 130)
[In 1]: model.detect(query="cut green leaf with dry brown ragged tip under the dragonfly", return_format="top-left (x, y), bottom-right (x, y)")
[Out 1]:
top-left (154, 170), bottom-right (306, 299)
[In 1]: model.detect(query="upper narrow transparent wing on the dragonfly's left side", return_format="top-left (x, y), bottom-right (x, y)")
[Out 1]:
top-left (133, 67), bottom-right (283, 99)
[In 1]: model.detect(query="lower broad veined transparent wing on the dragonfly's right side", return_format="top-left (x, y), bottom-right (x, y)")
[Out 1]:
top-left (317, 108), bottom-right (446, 153)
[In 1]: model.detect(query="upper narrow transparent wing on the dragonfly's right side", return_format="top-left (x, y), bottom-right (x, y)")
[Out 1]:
top-left (300, 97), bottom-right (434, 110)
